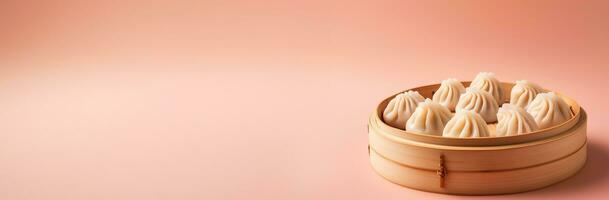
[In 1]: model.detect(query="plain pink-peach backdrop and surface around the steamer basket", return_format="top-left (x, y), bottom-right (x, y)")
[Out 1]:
top-left (0, 0), bottom-right (609, 200)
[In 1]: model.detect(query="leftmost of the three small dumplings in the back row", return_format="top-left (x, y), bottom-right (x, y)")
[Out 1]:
top-left (433, 78), bottom-right (465, 111)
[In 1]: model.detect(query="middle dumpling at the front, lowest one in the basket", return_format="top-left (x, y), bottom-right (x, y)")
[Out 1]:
top-left (442, 110), bottom-right (490, 138)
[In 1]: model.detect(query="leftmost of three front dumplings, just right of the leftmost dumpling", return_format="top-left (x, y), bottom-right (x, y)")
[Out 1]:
top-left (406, 99), bottom-right (452, 136)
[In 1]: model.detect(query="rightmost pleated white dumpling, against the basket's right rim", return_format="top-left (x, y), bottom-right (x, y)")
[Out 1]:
top-left (527, 92), bottom-right (572, 129)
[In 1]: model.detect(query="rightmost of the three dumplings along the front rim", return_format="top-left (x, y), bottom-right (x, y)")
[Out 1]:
top-left (496, 103), bottom-right (539, 136)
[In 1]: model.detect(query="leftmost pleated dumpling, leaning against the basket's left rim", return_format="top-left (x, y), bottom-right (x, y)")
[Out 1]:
top-left (383, 91), bottom-right (425, 130)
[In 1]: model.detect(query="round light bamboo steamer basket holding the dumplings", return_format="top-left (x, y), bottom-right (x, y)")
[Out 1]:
top-left (368, 82), bottom-right (587, 195)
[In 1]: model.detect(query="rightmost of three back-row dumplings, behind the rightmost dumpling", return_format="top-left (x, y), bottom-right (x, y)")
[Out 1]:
top-left (510, 80), bottom-right (544, 108)
